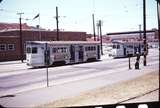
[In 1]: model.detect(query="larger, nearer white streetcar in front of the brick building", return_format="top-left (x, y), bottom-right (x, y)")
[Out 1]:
top-left (26, 41), bottom-right (100, 67)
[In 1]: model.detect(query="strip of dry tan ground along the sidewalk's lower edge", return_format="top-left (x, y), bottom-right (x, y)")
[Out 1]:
top-left (38, 72), bottom-right (159, 107)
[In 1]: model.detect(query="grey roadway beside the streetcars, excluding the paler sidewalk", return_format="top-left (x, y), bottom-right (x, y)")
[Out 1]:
top-left (0, 49), bottom-right (158, 95)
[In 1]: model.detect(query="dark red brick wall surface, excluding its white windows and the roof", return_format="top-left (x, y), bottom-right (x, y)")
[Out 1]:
top-left (0, 30), bottom-right (86, 61)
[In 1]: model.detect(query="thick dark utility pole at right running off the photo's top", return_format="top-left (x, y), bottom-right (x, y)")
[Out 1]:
top-left (143, 0), bottom-right (148, 66)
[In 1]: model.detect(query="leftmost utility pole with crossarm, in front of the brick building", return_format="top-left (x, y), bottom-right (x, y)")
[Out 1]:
top-left (17, 12), bottom-right (24, 63)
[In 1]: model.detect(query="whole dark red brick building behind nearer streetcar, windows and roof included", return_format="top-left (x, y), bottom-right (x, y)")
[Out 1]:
top-left (0, 24), bottom-right (86, 61)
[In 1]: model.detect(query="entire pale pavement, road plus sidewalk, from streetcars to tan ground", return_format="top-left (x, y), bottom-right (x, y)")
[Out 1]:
top-left (0, 51), bottom-right (159, 107)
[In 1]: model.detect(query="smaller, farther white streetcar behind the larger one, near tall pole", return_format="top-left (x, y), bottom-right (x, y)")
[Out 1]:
top-left (111, 41), bottom-right (144, 58)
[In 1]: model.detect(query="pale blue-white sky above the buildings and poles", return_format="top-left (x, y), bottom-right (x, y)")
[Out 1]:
top-left (0, 0), bottom-right (158, 34)
